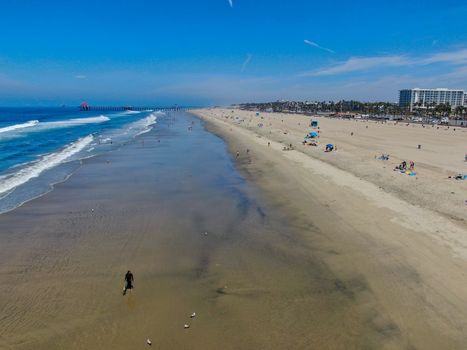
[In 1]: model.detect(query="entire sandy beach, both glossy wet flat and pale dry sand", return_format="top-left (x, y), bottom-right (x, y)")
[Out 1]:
top-left (0, 109), bottom-right (467, 350)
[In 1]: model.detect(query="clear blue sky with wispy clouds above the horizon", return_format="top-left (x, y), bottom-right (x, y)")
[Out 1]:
top-left (0, 0), bottom-right (467, 105)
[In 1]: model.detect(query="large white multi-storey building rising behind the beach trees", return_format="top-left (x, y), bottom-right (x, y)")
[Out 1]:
top-left (399, 88), bottom-right (467, 111)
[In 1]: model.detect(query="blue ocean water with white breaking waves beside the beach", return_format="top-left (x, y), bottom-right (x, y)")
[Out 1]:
top-left (0, 108), bottom-right (164, 213)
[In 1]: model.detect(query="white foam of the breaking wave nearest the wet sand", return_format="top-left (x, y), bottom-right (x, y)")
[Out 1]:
top-left (0, 135), bottom-right (94, 194)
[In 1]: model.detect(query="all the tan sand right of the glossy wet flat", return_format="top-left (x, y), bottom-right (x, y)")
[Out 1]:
top-left (198, 109), bottom-right (467, 349)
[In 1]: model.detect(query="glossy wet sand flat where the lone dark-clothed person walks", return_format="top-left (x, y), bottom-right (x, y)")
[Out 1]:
top-left (0, 114), bottom-right (381, 350)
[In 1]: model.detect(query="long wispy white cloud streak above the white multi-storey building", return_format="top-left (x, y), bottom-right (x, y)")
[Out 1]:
top-left (301, 49), bottom-right (467, 76)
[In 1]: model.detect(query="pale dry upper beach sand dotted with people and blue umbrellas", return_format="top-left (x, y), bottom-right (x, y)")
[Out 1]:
top-left (203, 109), bottom-right (467, 222)
